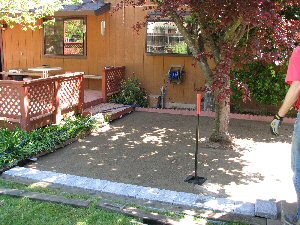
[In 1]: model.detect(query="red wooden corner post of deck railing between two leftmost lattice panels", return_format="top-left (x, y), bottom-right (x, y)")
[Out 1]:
top-left (18, 83), bottom-right (31, 131)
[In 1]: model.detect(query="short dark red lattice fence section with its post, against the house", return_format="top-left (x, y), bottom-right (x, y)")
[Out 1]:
top-left (102, 66), bottom-right (125, 102)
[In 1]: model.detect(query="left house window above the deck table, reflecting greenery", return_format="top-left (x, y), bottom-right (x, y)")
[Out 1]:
top-left (44, 18), bottom-right (86, 56)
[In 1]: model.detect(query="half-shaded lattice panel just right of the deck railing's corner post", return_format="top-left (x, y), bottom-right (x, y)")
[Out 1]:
top-left (28, 81), bottom-right (55, 117)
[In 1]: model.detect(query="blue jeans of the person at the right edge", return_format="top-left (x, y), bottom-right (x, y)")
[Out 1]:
top-left (291, 110), bottom-right (300, 219)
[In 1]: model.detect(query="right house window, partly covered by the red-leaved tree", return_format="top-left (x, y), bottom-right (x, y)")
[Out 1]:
top-left (146, 21), bottom-right (190, 55)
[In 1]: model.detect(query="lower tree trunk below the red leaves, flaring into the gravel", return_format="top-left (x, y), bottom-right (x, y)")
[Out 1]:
top-left (209, 96), bottom-right (231, 144)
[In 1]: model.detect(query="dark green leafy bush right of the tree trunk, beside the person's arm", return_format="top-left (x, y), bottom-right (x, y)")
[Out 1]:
top-left (231, 61), bottom-right (288, 111)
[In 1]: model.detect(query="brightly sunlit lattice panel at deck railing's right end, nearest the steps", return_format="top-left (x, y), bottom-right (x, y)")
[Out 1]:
top-left (58, 77), bottom-right (81, 109)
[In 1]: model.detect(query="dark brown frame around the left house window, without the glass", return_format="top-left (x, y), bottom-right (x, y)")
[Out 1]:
top-left (42, 16), bottom-right (88, 59)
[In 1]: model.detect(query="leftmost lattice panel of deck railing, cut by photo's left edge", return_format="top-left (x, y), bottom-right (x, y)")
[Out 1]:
top-left (0, 84), bottom-right (21, 118)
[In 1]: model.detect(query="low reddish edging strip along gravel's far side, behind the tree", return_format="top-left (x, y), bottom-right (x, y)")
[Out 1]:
top-left (135, 107), bottom-right (296, 124)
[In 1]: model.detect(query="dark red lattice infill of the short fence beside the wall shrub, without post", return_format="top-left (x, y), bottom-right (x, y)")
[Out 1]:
top-left (106, 67), bottom-right (125, 95)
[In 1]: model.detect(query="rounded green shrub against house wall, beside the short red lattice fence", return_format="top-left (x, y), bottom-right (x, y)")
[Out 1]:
top-left (109, 77), bottom-right (148, 107)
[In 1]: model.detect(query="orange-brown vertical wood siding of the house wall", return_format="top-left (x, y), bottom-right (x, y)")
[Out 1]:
top-left (2, 1), bottom-right (205, 104)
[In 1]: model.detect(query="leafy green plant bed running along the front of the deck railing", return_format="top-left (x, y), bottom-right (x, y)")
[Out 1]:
top-left (0, 116), bottom-right (95, 169)
